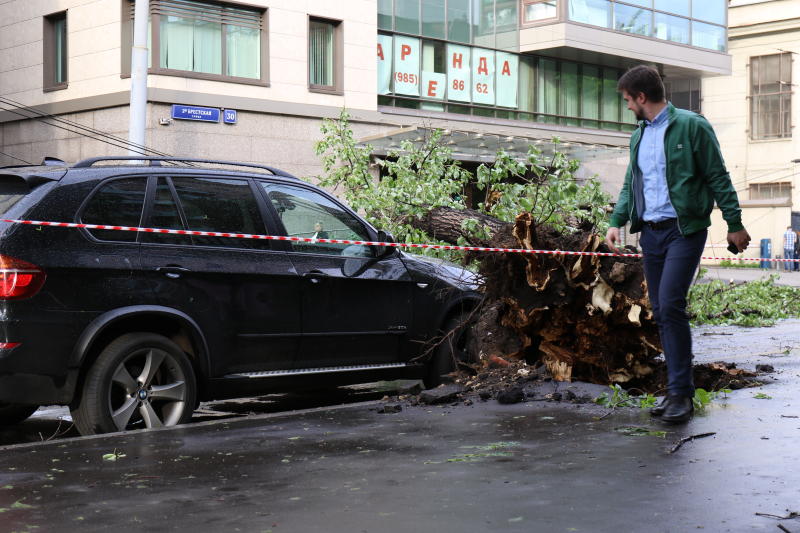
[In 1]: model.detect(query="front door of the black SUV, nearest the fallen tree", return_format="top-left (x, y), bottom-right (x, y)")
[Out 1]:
top-left (259, 181), bottom-right (413, 368)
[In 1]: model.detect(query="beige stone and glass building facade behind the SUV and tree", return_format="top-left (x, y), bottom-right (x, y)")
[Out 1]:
top-left (0, 0), bottom-right (731, 215)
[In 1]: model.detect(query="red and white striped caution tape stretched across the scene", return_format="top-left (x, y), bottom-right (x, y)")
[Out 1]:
top-left (0, 218), bottom-right (800, 263)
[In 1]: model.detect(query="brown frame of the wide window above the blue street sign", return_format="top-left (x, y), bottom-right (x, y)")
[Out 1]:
top-left (120, 0), bottom-right (270, 87)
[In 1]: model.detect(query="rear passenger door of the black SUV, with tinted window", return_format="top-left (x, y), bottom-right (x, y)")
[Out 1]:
top-left (136, 175), bottom-right (301, 377)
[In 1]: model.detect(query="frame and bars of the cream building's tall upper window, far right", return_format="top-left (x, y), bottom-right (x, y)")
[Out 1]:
top-left (748, 52), bottom-right (794, 141)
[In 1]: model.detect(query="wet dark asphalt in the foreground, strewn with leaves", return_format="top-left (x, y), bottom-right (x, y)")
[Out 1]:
top-left (0, 320), bottom-right (800, 533)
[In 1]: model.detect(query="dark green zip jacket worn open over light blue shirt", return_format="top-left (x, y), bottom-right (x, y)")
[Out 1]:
top-left (610, 104), bottom-right (744, 235)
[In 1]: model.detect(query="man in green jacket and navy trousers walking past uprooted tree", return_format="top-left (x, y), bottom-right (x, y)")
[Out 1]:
top-left (606, 65), bottom-right (750, 423)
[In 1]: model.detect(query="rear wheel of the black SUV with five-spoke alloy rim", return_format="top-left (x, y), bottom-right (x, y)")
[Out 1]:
top-left (72, 333), bottom-right (197, 435)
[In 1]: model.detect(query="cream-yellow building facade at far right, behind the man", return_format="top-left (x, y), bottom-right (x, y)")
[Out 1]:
top-left (702, 0), bottom-right (800, 264)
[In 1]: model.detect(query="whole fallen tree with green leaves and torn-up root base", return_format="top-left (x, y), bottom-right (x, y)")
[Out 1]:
top-left (317, 113), bottom-right (661, 386)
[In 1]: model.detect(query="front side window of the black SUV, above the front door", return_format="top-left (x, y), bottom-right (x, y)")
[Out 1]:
top-left (259, 182), bottom-right (375, 257)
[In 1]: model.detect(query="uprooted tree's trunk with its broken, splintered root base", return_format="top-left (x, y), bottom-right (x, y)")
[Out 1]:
top-left (414, 208), bottom-right (661, 387)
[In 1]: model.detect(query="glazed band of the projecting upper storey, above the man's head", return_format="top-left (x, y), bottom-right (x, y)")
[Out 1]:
top-left (520, 0), bottom-right (727, 52)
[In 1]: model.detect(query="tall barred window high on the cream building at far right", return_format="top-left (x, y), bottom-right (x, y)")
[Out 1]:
top-left (750, 53), bottom-right (792, 139)
